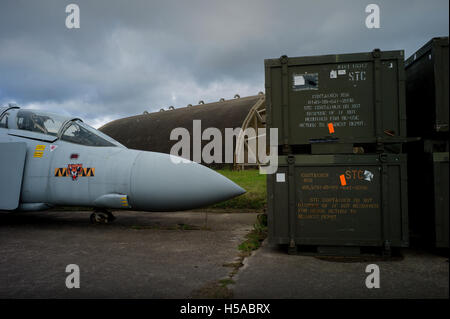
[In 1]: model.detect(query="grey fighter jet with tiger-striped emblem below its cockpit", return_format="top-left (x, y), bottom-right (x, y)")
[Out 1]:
top-left (0, 105), bottom-right (245, 222)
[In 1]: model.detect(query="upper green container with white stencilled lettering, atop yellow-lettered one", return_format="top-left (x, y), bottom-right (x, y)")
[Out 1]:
top-left (265, 50), bottom-right (406, 152)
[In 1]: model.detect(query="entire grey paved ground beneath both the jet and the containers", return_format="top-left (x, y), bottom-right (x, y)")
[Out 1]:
top-left (0, 211), bottom-right (449, 299)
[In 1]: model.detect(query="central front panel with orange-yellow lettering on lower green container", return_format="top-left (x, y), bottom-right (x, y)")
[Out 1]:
top-left (296, 165), bottom-right (382, 246)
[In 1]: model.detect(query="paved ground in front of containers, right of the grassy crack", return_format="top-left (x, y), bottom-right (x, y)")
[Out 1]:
top-left (233, 242), bottom-right (449, 299)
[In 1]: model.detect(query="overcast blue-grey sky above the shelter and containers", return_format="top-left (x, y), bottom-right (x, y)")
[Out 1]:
top-left (0, 0), bottom-right (449, 127)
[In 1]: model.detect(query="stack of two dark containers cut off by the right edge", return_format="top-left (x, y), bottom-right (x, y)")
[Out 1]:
top-left (405, 37), bottom-right (449, 248)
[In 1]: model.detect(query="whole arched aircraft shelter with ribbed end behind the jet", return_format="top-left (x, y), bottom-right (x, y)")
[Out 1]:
top-left (99, 92), bottom-right (266, 168)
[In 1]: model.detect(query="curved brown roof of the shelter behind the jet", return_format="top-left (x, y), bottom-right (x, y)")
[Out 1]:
top-left (100, 93), bottom-right (265, 164)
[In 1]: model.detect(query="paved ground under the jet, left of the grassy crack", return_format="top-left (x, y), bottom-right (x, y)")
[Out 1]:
top-left (0, 211), bottom-right (256, 298)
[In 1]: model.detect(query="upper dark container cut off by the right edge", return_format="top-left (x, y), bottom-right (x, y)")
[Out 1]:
top-left (405, 37), bottom-right (449, 138)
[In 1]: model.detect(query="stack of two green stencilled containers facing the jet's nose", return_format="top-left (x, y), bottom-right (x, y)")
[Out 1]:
top-left (265, 49), bottom-right (409, 254)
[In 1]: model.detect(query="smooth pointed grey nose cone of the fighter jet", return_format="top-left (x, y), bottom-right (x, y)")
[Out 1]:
top-left (130, 152), bottom-right (245, 211)
